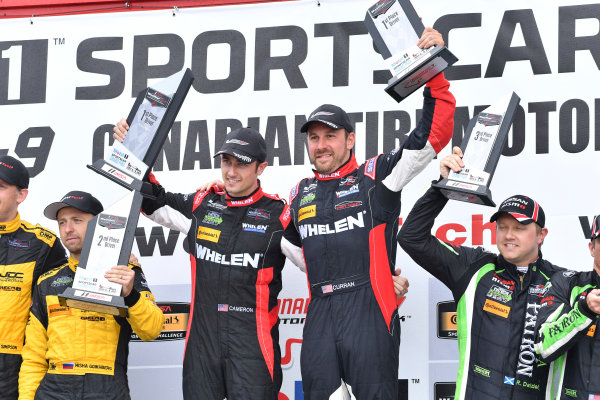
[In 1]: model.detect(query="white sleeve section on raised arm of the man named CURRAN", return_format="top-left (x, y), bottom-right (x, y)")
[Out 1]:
top-left (383, 142), bottom-right (435, 192)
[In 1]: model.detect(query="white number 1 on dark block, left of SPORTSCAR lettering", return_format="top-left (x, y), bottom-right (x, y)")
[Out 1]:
top-left (0, 39), bottom-right (48, 105)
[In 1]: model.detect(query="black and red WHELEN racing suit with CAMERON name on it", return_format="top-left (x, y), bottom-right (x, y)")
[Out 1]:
top-left (143, 180), bottom-right (300, 400)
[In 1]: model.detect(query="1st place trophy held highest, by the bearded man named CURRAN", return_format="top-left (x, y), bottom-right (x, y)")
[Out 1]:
top-left (365, 0), bottom-right (458, 102)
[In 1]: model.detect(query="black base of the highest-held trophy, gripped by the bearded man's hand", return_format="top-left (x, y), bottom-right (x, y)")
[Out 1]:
top-left (385, 46), bottom-right (458, 103)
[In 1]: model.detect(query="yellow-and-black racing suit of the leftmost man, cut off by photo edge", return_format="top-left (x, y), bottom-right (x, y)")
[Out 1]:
top-left (0, 214), bottom-right (66, 400)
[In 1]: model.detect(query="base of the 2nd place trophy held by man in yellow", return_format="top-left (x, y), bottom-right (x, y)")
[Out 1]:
top-left (58, 287), bottom-right (129, 317)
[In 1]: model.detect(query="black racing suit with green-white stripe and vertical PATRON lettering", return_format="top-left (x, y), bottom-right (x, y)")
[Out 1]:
top-left (398, 188), bottom-right (562, 400)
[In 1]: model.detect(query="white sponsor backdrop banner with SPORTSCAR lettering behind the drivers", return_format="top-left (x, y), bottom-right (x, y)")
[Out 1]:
top-left (0, 0), bottom-right (600, 400)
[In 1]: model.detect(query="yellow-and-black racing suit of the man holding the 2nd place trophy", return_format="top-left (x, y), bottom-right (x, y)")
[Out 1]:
top-left (19, 258), bottom-right (164, 400)
